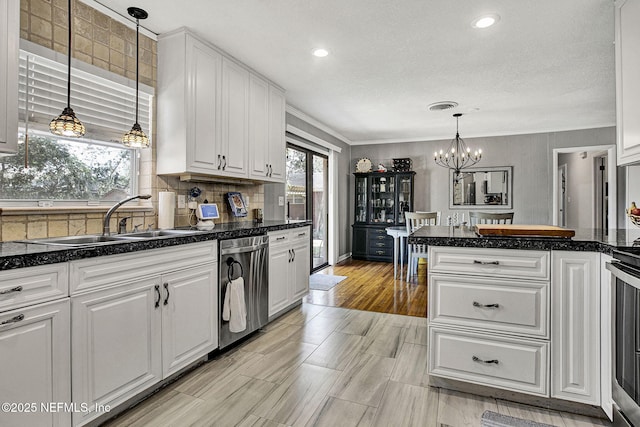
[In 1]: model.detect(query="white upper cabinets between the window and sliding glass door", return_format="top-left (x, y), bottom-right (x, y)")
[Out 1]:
top-left (157, 29), bottom-right (285, 182)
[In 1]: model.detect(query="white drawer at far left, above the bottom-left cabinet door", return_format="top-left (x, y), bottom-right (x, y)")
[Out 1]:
top-left (0, 262), bottom-right (69, 311)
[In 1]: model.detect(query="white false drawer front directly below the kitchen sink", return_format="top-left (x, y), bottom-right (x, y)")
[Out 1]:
top-left (69, 240), bottom-right (218, 295)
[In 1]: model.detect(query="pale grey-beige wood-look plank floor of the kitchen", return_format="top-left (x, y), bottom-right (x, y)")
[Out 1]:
top-left (106, 304), bottom-right (610, 427)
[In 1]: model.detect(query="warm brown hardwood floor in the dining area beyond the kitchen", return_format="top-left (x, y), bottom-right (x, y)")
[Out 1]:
top-left (304, 258), bottom-right (427, 317)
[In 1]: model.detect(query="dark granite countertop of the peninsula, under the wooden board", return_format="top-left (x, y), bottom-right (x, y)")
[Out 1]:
top-left (408, 226), bottom-right (640, 254)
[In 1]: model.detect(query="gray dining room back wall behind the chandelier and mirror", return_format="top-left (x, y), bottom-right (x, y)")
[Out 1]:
top-left (347, 127), bottom-right (616, 224)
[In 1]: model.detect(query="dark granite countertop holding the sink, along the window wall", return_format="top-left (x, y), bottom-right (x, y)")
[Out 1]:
top-left (0, 221), bottom-right (311, 270)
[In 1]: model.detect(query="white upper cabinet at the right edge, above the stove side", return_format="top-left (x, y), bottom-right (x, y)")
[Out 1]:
top-left (615, 0), bottom-right (640, 166)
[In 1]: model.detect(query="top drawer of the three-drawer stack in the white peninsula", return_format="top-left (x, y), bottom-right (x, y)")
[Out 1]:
top-left (429, 246), bottom-right (550, 280)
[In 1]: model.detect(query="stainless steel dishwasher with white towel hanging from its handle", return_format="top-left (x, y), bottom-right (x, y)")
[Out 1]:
top-left (218, 236), bottom-right (269, 348)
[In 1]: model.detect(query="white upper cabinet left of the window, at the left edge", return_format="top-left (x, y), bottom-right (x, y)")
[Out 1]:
top-left (0, 0), bottom-right (20, 156)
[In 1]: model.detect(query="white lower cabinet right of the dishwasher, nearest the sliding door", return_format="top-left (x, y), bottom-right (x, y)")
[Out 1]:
top-left (268, 227), bottom-right (311, 316)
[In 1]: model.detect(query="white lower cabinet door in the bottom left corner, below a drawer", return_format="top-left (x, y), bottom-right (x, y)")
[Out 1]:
top-left (0, 298), bottom-right (71, 427)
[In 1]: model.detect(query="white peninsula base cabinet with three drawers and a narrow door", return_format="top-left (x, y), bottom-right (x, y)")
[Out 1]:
top-left (428, 247), bottom-right (601, 405)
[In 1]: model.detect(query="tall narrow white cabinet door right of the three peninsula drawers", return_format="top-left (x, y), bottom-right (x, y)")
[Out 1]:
top-left (551, 251), bottom-right (600, 405)
